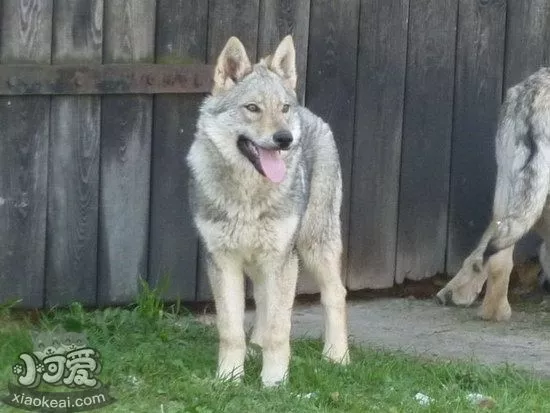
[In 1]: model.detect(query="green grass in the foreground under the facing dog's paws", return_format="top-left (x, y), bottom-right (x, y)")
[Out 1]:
top-left (0, 286), bottom-right (550, 413)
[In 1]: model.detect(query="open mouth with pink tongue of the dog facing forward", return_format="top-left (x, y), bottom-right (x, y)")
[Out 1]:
top-left (237, 135), bottom-right (286, 183)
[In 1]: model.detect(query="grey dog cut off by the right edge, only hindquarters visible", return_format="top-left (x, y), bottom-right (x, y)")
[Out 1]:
top-left (437, 68), bottom-right (550, 321)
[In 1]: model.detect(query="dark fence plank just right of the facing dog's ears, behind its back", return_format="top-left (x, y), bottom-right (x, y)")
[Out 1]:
top-left (298, 0), bottom-right (359, 293)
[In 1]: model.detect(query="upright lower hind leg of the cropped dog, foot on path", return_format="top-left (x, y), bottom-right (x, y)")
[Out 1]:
top-left (480, 245), bottom-right (514, 321)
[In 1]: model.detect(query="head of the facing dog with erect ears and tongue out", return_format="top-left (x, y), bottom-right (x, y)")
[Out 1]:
top-left (198, 36), bottom-right (300, 183)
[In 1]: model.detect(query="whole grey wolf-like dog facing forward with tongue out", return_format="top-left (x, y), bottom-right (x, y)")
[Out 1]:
top-left (187, 36), bottom-right (349, 386)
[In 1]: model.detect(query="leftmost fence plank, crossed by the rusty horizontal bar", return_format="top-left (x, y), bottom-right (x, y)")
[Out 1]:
top-left (0, 0), bottom-right (52, 308)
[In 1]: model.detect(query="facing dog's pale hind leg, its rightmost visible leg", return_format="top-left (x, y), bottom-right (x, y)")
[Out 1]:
top-left (301, 245), bottom-right (349, 364)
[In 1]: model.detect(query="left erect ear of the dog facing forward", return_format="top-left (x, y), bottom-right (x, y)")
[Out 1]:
top-left (212, 37), bottom-right (252, 94)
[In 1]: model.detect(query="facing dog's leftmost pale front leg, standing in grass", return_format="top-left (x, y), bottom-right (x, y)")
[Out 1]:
top-left (208, 255), bottom-right (246, 380)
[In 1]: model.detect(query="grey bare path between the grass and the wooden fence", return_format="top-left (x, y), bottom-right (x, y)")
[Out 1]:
top-left (247, 299), bottom-right (550, 377)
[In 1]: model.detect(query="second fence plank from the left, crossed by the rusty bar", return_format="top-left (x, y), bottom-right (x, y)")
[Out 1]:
top-left (46, 0), bottom-right (103, 306)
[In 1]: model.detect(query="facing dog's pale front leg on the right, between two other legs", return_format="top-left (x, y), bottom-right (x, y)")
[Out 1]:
top-left (261, 254), bottom-right (298, 387)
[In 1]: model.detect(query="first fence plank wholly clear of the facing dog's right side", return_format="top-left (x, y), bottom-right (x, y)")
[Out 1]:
top-left (348, 0), bottom-right (409, 289)
